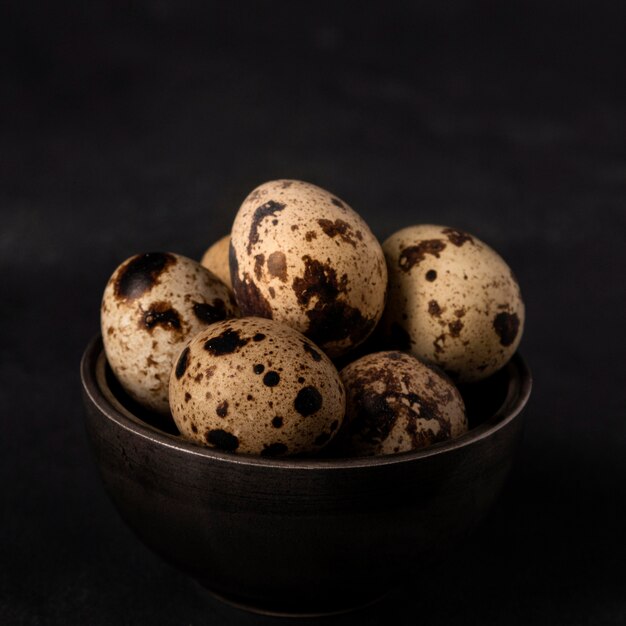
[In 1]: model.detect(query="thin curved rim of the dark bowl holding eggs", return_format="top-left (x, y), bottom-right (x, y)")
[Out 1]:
top-left (80, 333), bottom-right (532, 470)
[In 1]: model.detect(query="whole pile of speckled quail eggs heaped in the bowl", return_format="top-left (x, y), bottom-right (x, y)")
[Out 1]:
top-left (101, 180), bottom-right (524, 457)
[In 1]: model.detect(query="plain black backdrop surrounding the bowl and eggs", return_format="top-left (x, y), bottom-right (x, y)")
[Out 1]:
top-left (0, 0), bottom-right (626, 626)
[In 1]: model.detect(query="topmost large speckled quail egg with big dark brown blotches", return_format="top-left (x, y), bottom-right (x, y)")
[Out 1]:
top-left (230, 180), bottom-right (387, 357)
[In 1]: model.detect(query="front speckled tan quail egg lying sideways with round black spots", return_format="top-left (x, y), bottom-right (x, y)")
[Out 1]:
top-left (170, 317), bottom-right (345, 456)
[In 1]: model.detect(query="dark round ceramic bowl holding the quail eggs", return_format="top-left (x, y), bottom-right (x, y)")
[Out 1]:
top-left (81, 338), bottom-right (531, 614)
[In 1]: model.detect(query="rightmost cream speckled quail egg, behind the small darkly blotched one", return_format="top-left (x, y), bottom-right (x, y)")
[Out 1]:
top-left (381, 225), bottom-right (524, 382)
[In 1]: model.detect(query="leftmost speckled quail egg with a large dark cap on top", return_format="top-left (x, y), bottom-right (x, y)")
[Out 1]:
top-left (100, 252), bottom-right (238, 413)
